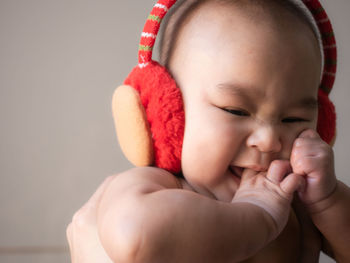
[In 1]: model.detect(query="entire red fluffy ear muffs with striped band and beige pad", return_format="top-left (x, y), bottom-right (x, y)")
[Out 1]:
top-left (112, 0), bottom-right (337, 174)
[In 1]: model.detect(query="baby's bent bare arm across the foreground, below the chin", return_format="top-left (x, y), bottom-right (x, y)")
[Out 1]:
top-left (98, 168), bottom-right (296, 263)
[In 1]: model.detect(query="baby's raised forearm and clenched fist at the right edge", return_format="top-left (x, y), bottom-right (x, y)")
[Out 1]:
top-left (291, 130), bottom-right (350, 262)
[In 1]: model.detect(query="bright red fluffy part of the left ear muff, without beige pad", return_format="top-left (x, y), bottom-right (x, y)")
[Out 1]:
top-left (125, 61), bottom-right (185, 173)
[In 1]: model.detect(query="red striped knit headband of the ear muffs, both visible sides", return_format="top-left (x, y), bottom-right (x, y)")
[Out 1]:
top-left (138, 0), bottom-right (337, 95)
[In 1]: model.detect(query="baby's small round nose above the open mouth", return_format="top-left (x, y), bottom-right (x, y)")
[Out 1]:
top-left (247, 124), bottom-right (282, 153)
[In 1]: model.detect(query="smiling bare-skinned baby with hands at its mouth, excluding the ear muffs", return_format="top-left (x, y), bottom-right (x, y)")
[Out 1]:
top-left (67, 0), bottom-right (350, 263)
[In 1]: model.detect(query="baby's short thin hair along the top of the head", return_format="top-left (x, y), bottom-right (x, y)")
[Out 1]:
top-left (159, 0), bottom-right (323, 69)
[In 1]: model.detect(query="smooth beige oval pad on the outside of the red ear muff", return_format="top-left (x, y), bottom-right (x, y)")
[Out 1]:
top-left (112, 85), bottom-right (153, 166)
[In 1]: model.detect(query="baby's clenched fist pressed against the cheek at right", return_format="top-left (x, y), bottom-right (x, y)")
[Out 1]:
top-left (290, 129), bottom-right (337, 206)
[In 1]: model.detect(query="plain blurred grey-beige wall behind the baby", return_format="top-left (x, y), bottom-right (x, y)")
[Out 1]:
top-left (0, 0), bottom-right (350, 263)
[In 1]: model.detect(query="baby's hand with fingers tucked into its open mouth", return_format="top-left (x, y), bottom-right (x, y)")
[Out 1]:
top-left (232, 160), bottom-right (305, 236)
